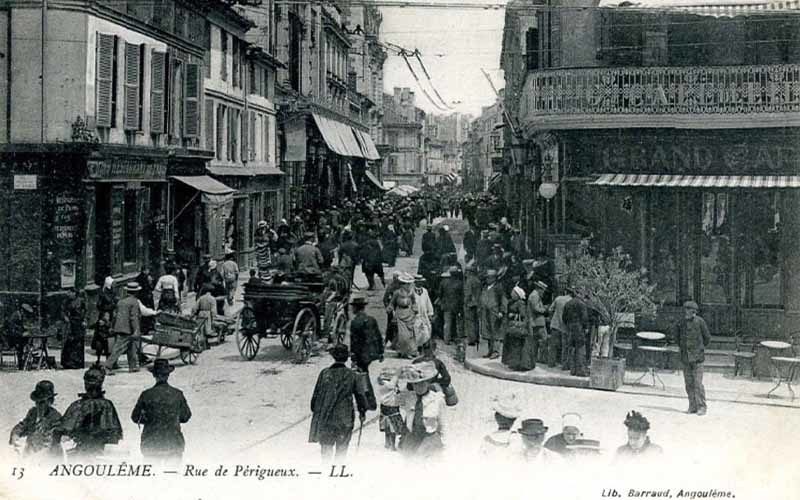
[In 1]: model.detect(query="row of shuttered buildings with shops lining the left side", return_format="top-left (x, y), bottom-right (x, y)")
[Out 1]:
top-left (0, 0), bottom-right (386, 323)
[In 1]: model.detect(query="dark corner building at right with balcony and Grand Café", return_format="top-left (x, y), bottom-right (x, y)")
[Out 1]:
top-left (488, 0), bottom-right (800, 337)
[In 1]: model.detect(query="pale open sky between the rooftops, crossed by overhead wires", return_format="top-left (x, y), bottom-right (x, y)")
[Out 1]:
top-left (381, 0), bottom-right (505, 116)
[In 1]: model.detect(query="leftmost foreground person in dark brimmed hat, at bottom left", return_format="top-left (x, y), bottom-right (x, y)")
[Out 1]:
top-left (9, 380), bottom-right (62, 458)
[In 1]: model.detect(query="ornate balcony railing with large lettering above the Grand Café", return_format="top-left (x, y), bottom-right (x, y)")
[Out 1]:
top-left (520, 64), bottom-right (800, 126)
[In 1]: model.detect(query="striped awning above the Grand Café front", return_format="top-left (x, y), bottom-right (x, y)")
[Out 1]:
top-left (592, 174), bottom-right (800, 189)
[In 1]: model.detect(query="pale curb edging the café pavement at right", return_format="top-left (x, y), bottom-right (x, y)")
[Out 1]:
top-left (464, 359), bottom-right (800, 410)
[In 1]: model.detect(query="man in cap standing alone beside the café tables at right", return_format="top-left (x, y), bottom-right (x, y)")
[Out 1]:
top-left (674, 300), bottom-right (711, 416)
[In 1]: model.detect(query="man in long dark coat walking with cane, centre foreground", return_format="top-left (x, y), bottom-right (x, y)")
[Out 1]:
top-left (308, 344), bottom-right (367, 459)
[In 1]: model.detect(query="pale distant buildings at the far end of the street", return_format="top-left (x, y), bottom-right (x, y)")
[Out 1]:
top-left (383, 88), bottom-right (472, 187)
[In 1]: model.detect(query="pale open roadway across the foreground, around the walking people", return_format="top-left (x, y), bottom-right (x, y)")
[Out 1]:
top-left (0, 221), bottom-right (800, 498)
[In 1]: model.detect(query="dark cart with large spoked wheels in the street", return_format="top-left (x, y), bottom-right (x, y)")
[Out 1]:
top-left (236, 274), bottom-right (349, 362)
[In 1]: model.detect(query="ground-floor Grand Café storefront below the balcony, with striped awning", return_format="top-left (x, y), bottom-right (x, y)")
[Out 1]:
top-left (548, 129), bottom-right (800, 337)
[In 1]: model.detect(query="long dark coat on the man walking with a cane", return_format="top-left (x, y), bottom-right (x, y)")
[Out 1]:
top-left (308, 363), bottom-right (367, 443)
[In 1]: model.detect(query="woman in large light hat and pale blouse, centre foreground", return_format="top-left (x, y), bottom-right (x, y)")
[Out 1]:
top-left (399, 361), bottom-right (446, 458)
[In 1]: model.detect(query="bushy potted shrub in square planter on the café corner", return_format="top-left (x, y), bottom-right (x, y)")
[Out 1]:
top-left (565, 247), bottom-right (656, 390)
